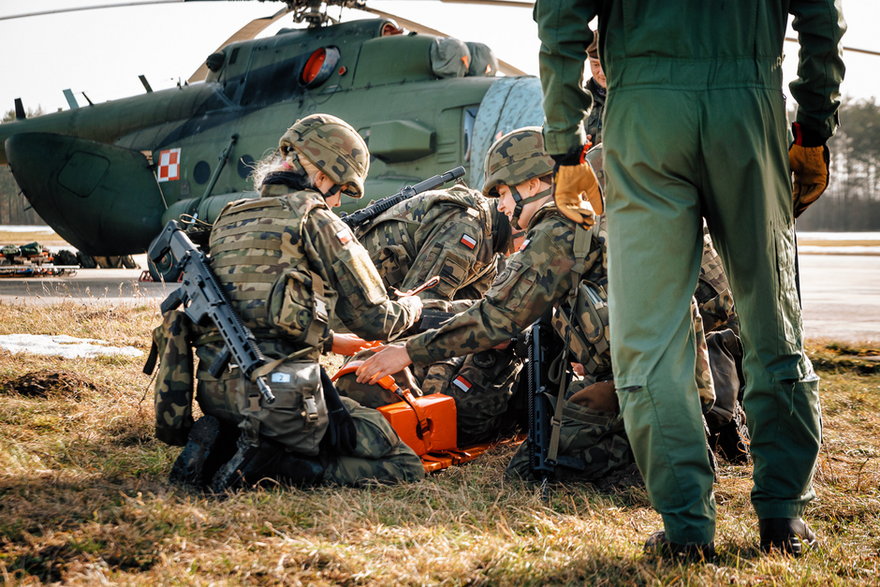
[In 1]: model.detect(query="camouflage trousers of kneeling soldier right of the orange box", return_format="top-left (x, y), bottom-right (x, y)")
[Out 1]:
top-left (505, 381), bottom-right (641, 488)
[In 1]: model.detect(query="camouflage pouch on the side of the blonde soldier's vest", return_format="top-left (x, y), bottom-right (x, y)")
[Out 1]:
top-left (267, 269), bottom-right (335, 347)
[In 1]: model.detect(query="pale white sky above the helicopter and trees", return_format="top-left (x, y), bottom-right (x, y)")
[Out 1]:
top-left (0, 0), bottom-right (880, 117)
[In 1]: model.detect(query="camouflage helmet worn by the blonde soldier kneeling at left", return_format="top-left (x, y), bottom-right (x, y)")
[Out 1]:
top-left (278, 114), bottom-right (370, 198)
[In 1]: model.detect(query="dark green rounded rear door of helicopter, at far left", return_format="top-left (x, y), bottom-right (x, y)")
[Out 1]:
top-left (6, 133), bottom-right (166, 255)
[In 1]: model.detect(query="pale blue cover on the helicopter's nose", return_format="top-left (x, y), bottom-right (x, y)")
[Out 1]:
top-left (468, 77), bottom-right (544, 189)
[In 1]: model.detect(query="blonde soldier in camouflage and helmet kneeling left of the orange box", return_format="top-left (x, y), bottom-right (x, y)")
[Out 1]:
top-left (156, 114), bottom-right (424, 492)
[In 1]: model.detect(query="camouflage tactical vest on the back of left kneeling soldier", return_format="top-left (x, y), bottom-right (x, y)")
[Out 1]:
top-left (210, 186), bottom-right (334, 350)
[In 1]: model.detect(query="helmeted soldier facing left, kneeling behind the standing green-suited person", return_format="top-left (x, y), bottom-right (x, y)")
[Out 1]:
top-left (358, 134), bottom-right (733, 485)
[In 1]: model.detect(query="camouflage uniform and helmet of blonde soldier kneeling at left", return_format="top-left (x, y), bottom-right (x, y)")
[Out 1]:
top-left (157, 115), bottom-right (423, 484)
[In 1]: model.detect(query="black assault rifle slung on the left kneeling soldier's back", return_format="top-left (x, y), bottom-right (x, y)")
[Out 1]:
top-left (148, 220), bottom-right (275, 404)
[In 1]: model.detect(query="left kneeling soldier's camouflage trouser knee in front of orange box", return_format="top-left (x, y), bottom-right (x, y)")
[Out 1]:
top-left (324, 397), bottom-right (425, 485)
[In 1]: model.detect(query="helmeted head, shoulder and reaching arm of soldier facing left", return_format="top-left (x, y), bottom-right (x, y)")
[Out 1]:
top-left (358, 127), bottom-right (605, 440)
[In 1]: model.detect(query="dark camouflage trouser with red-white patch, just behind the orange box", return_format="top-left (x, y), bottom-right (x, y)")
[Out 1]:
top-left (414, 350), bottom-right (522, 446)
